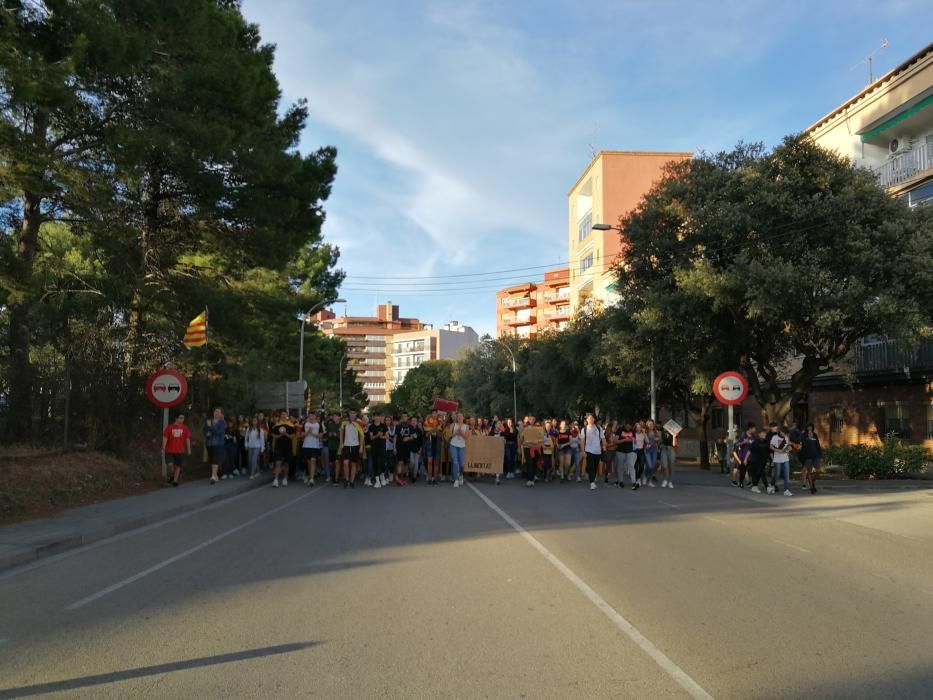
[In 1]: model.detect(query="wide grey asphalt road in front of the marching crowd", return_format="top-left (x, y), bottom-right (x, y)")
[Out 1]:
top-left (0, 477), bottom-right (933, 698)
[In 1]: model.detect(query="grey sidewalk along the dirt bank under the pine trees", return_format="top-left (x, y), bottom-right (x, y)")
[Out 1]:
top-left (0, 472), bottom-right (269, 571)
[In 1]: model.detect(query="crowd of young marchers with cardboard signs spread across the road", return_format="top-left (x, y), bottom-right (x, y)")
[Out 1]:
top-left (162, 408), bottom-right (822, 496)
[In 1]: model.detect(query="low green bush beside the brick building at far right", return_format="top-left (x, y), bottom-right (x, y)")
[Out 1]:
top-left (823, 433), bottom-right (933, 479)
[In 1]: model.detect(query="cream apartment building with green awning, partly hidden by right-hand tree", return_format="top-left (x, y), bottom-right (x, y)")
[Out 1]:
top-left (797, 44), bottom-right (933, 447)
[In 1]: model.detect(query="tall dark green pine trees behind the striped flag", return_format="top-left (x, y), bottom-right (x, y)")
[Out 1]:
top-left (0, 0), bottom-right (342, 446)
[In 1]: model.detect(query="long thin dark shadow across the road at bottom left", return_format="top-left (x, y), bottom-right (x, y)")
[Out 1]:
top-left (0, 642), bottom-right (321, 698)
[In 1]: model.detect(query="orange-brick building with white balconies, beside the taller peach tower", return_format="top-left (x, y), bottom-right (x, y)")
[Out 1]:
top-left (496, 268), bottom-right (571, 338)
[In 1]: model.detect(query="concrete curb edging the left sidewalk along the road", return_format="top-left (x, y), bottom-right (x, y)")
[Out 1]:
top-left (0, 475), bottom-right (269, 573)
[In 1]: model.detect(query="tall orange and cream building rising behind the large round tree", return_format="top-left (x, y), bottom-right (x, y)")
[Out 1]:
top-left (567, 151), bottom-right (692, 313)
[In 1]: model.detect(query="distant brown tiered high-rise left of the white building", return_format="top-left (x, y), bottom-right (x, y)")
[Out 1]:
top-left (315, 301), bottom-right (424, 404)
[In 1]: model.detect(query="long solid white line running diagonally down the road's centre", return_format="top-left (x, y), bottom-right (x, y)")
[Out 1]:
top-left (466, 482), bottom-right (713, 700)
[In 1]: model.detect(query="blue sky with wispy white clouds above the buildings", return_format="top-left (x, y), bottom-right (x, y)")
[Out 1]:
top-left (243, 0), bottom-right (933, 340)
